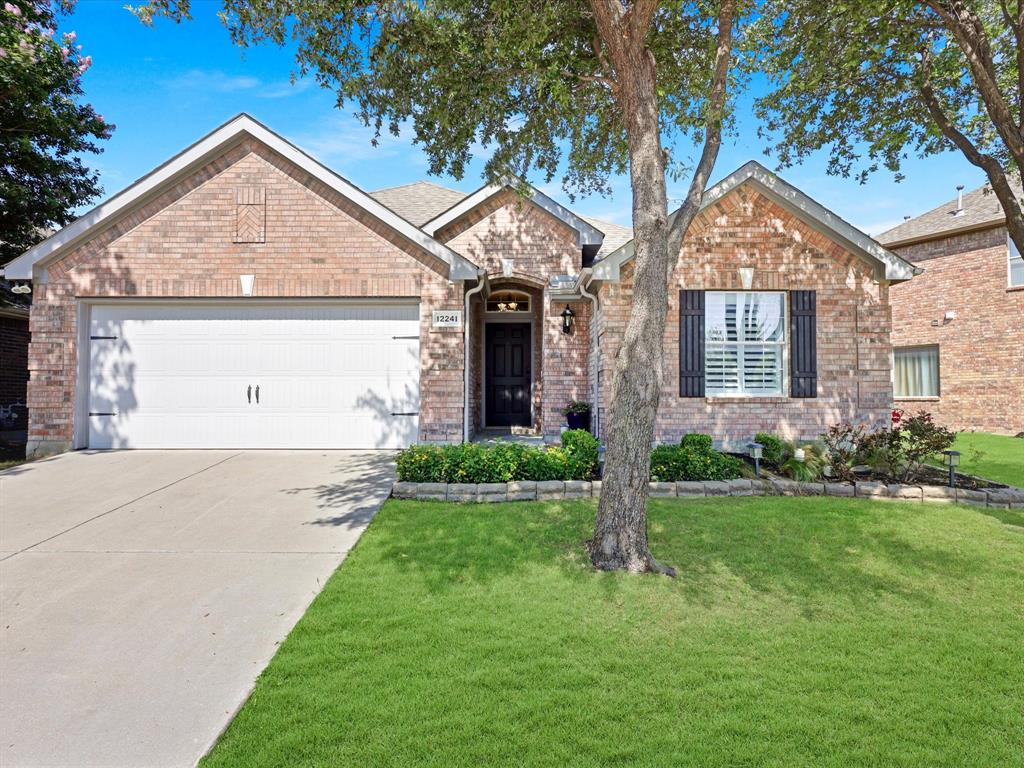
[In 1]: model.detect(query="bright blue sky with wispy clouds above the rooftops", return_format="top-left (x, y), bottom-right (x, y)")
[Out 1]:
top-left (61, 0), bottom-right (984, 234)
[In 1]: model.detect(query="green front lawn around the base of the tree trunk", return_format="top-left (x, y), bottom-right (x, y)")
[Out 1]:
top-left (203, 498), bottom-right (1024, 768)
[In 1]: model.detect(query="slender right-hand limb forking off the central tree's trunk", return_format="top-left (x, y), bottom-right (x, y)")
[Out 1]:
top-left (669, 0), bottom-right (736, 259)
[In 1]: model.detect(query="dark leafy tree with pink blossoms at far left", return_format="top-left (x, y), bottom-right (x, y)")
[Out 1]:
top-left (0, 0), bottom-right (114, 264)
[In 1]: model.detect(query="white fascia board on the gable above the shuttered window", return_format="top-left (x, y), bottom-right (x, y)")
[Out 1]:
top-left (594, 160), bottom-right (922, 283)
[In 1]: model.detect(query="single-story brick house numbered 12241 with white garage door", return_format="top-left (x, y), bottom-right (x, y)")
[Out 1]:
top-left (6, 115), bottom-right (914, 454)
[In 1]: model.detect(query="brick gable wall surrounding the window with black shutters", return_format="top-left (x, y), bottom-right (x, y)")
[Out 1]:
top-left (598, 186), bottom-right (892, 444)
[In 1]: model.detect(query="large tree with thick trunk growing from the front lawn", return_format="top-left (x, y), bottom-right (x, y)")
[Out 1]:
top-left (136, 0), bottom-right (738, 572)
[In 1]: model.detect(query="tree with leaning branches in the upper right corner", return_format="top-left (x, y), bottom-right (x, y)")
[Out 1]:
top-left (759, 0), bottom-right (1024, 252)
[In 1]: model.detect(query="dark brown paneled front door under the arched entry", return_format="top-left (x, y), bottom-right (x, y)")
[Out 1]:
top-left (484, 323), bottom-right (534, 427)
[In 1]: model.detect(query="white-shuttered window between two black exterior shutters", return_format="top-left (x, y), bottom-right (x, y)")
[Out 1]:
top-left (705, 291), bottom-right (786, 396)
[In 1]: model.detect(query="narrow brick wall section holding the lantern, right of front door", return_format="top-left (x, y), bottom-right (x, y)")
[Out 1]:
top-left (542, 299), bottom-right (591, 437)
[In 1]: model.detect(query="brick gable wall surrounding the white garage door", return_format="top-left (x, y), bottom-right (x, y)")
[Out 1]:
top-left (29, 140), bottom-right (463, 454)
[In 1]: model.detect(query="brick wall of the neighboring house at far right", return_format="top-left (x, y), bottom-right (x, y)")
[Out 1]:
top-left (891, 226), bottom-right (1024, 434)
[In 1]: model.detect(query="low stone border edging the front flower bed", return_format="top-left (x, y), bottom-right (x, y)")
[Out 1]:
top-left (391, 479), bottom-right (1024, 509)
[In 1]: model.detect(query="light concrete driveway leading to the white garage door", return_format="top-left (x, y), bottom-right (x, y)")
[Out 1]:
top-left (0, 451), bottom-right (393, 766)
